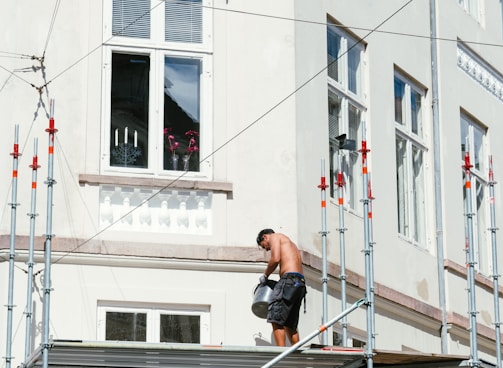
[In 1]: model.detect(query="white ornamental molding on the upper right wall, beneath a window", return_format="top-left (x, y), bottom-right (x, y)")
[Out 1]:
top-left (457, 44), bottom-right (503, 101)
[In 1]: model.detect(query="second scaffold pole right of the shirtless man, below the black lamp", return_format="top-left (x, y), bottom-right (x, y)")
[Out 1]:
top-left (335, 149), bottom-right (348, 346)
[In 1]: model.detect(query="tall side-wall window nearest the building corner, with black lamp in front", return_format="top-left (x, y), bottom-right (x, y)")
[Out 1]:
top-left (327, 21), bottom-right (365, 211)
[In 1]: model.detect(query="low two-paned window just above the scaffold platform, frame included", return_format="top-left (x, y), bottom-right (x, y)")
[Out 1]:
top-left (98, 306), bottom-right (209, 344)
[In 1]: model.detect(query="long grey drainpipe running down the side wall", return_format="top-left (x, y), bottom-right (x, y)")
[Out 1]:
top-left (430, 0), bottom-right (448, 354)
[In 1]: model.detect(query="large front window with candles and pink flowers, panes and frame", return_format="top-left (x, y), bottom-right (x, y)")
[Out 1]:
top-left (104, 0), bottom-right (211, 177)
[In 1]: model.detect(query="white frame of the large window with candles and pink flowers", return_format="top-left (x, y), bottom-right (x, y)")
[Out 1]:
top-left (101, 0), bottom-right (213, 180)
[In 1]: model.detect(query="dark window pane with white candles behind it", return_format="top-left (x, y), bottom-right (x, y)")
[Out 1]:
top-left (110, 53), bottom-right (150, 167)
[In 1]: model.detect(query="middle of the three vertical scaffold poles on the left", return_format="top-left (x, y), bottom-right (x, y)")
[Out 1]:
top-left (24, 138), bottom-right (40, 361)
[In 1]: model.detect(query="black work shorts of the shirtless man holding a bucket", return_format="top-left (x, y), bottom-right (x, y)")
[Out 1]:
top-left (267, 272), bottom-right (306, 331)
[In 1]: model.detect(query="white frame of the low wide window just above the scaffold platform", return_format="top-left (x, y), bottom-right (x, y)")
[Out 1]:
top-left (96, 302), bottom-right (210, 344)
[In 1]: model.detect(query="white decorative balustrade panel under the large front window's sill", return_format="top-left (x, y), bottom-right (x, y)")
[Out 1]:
top-left (100, 185), bottom-right (212, 234)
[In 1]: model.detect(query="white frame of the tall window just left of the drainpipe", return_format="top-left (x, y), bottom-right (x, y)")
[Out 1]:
top-left (393, 72), bottom-right (429, 248)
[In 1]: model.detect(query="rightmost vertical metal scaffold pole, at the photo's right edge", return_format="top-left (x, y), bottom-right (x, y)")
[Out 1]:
top-left (489, 156), bottom-right (501, 368)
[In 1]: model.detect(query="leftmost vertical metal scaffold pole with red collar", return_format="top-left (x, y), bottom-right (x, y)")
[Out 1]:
top-left (5, 125), bottom-right (21, 368)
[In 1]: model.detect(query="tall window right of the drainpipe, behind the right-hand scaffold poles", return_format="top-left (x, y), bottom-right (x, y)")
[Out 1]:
top-left (461, 114), bottom-right (491, 274)
